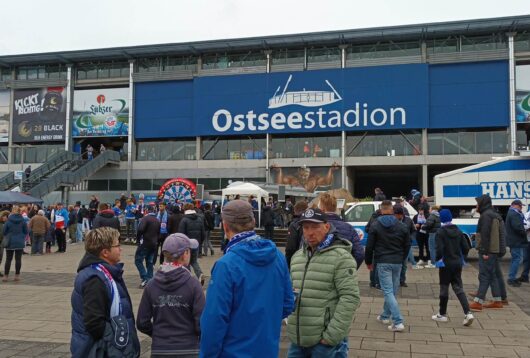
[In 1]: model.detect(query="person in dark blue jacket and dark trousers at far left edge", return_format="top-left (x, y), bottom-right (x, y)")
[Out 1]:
top-left (2, 205), bottom-right (28, 282)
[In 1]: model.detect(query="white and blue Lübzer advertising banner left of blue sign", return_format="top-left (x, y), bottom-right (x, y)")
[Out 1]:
top-left (72, 88), bottom-right (129, 137)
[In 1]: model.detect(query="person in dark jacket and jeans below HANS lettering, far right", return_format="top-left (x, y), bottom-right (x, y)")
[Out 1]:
top-left (504, 200), bottom-right (528, 287)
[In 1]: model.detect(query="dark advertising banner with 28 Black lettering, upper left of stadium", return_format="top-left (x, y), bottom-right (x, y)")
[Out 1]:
top-left (13, 87), bottom-right (66, 143)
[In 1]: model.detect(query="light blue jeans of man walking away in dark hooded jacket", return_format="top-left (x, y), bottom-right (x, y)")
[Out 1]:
top-left (377, 263), bottom-right (403, 325)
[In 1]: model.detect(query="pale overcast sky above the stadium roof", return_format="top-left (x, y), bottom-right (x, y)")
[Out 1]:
top-left (0, 0), bottom-right (530, 55)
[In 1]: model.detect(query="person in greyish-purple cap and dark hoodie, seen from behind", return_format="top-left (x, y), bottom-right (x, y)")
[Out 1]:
top-left (136, 233), bottom-right (204, 358)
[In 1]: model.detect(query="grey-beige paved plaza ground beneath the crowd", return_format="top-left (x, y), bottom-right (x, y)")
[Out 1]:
top-left (0, 245), bottom-right (530, 358)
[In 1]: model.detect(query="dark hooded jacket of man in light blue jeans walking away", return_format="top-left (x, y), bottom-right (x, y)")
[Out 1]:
top-left (365, 215), bottom-right (410, 265)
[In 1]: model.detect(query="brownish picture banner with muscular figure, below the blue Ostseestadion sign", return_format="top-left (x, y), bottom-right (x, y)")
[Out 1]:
top-left (271, 163), bottom-right (341, 193)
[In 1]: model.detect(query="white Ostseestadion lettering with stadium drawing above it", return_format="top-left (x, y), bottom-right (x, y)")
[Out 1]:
top-left (212, 75), bottom-right (407, 133)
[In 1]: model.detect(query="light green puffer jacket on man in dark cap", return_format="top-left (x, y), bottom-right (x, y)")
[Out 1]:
top-left (287, 235), bottom-right (360, 347)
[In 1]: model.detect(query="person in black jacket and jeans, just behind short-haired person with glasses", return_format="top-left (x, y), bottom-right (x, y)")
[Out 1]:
top-left (134, 205), bottom-right (160, 288)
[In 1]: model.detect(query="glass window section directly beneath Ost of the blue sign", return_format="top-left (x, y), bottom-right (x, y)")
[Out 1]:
top-left (201, 136), bottom-right (267, 160)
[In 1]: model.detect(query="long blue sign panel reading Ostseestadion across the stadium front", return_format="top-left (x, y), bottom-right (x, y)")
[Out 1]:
top-left (135, 61), bottom-right (509, 139)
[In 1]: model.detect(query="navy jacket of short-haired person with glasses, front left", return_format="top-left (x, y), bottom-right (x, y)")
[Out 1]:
top-left (70, 253), bottom-right (140, 358)
